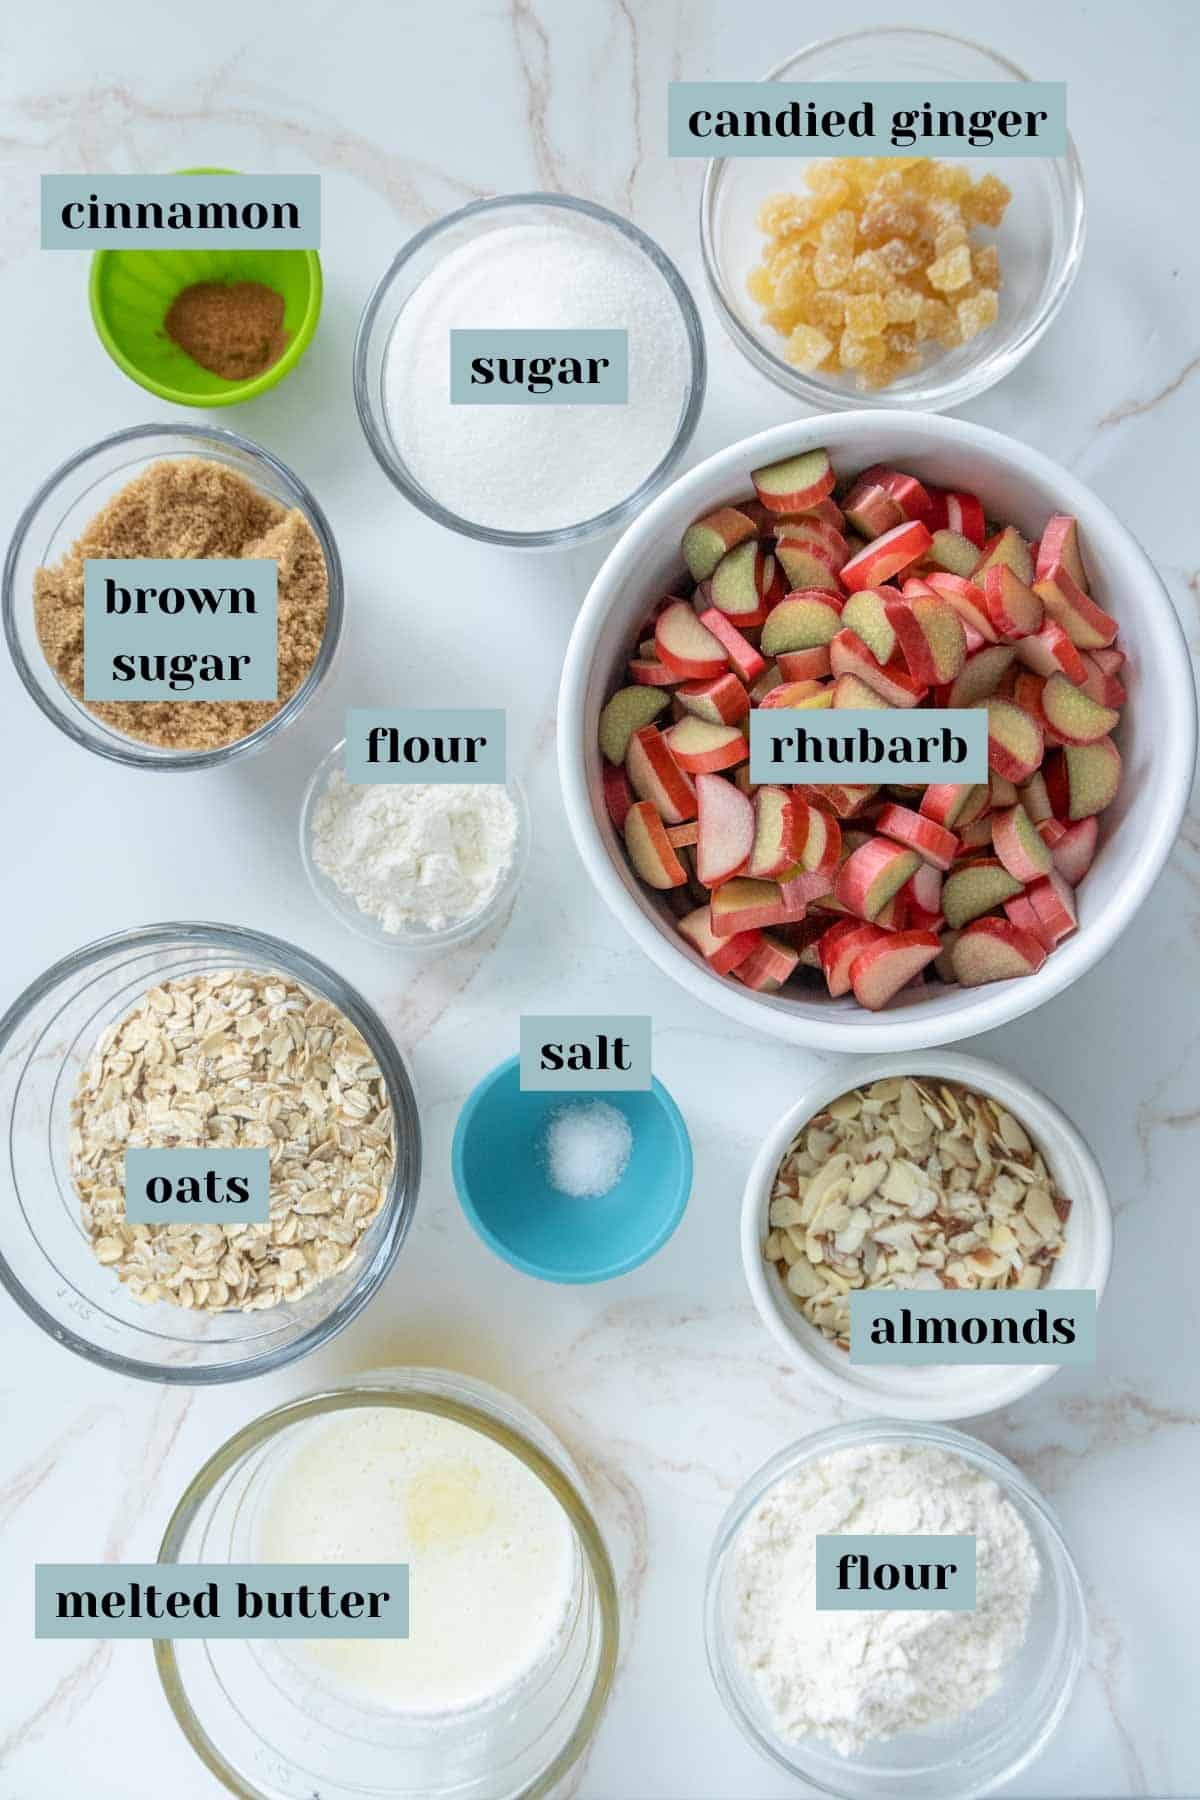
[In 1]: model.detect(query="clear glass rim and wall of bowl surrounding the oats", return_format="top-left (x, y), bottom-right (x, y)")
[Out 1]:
top-left (0, 920), bottom-right (421, 1388)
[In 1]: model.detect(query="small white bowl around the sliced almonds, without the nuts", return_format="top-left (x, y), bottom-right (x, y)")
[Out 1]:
top-left (741, 1049), bottom-right (1112, 1418)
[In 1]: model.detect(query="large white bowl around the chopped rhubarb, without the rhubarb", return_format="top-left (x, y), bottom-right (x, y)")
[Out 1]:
top-left (558, 412), bottom-right (1196, 1051)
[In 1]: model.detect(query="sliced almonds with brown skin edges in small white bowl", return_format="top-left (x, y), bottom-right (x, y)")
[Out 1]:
top-left (763, 1076), bottom-right (1070, 1350)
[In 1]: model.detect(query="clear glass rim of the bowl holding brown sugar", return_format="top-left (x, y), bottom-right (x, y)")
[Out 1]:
top-left (0, 421), bottom-right (345, 772)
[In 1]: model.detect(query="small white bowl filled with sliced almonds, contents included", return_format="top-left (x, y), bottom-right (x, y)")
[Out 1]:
top-left (741, 1049), bottom-right (1112, 1420)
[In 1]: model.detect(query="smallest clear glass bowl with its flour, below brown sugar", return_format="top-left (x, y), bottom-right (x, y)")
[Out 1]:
top-left (300, 742), bottom-right (529, 950)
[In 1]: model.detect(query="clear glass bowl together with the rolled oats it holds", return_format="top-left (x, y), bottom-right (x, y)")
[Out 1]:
top-left (0, 923), bottom-right (421, 1386)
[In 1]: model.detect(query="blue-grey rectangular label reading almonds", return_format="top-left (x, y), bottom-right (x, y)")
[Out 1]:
top-left (849, 1287), bottom-right (1096, 1364)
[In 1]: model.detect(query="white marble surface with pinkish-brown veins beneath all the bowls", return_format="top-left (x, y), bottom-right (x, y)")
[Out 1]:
top-left (0, 0), bottom-right (1200, 1800)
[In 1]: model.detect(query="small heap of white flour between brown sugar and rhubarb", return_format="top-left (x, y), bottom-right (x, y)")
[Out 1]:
top-left (313, 769), bottom-right (520, 931)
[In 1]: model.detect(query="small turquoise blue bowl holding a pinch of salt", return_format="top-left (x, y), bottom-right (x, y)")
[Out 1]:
top-left (452, 1057), bottom-right (691, 1282)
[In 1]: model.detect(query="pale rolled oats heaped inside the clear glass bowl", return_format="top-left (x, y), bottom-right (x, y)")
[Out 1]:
top-left (70, 970), bottom-right (396, 1312)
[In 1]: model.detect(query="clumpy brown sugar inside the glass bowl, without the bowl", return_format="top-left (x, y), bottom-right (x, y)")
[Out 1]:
top-left (34, 457), bottom-right (329, 751)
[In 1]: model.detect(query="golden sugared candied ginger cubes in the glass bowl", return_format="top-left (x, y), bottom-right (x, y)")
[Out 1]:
top-left (747, 157), bottom-right (1011, 387)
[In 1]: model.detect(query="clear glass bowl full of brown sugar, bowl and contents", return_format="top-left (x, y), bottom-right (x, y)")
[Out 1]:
top-left (2, 425), bottom-right (344, 769)
